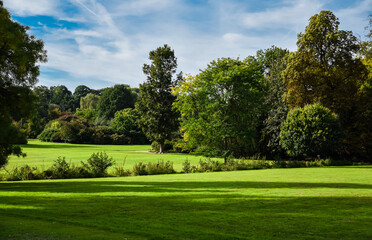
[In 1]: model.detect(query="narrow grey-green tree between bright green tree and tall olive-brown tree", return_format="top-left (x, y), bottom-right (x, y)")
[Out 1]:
top-left (257, 46), bottom-right (289, 157)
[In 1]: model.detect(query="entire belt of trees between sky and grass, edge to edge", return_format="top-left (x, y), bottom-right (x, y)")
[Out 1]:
top-left (0, 1), bottom-right (372, 171)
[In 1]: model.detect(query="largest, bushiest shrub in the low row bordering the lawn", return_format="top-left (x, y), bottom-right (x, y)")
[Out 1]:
top-left (81, 152), bottom-right (115, 177)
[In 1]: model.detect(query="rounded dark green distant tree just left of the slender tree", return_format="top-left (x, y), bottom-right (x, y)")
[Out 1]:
top-left (97, 84), bottom-right (135, 120)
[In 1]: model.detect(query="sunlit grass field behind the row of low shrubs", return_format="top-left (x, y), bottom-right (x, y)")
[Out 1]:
top-left (7, 139), bottom-right (218, 171)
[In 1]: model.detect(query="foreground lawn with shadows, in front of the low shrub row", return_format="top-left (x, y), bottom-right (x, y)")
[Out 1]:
top-left (0, 166), bottom-right (372, 239)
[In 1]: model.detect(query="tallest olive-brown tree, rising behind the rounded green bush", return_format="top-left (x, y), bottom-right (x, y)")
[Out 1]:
top-left (283, 11), bottom-right (368, 157)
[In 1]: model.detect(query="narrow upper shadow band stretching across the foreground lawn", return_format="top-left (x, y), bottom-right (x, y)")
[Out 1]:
top-left (0, 180), bottom-right (372, 193)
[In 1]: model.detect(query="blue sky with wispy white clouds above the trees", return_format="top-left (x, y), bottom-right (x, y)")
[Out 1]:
top-left (3, 0), bottom-right (372, 92)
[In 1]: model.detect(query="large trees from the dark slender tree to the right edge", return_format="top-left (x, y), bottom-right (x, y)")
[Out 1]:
top-left (137, 11), bottom-right (372, 160)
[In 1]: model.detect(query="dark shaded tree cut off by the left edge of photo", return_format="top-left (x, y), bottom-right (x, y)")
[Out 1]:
top-left (0, 1), bottom-right (46, 167)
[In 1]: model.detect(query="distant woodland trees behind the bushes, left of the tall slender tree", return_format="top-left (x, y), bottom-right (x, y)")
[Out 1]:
top-left (24, 84), bottom-right (138, 138)
